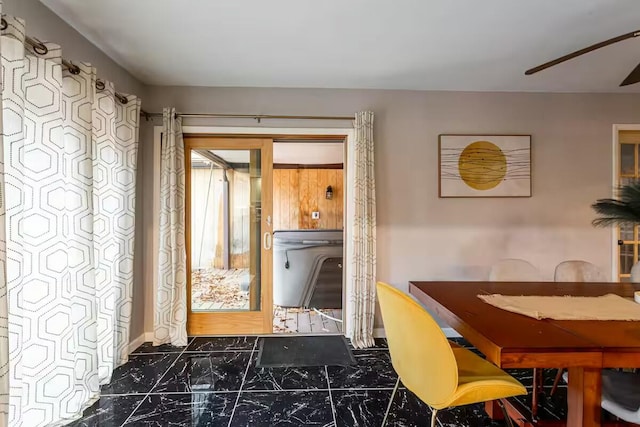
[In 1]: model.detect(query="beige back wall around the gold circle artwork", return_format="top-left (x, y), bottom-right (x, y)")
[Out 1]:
top-left (143, 87), bottom-right (640, 328)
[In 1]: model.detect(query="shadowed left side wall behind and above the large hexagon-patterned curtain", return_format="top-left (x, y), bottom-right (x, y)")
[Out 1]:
top-left (2, 0), bottom-right (152, 339)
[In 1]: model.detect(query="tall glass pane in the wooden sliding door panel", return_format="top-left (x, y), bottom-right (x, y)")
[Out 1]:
top-left (190, 149), bottom-right (262, 312)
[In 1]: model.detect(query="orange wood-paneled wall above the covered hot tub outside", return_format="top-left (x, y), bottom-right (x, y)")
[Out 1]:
top-left (273, 169), bottom-right (344, 230)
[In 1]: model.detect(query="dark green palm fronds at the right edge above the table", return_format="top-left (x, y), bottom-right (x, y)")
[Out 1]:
top-left (591, 182), bottom-right (640, 227)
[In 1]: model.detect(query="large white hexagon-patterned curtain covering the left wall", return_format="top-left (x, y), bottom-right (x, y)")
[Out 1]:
top-left (0, 16), bottom-right (140, 427)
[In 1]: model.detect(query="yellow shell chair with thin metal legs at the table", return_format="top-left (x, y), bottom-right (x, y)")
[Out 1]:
top-left (377, 282), bottom-right (527, 427)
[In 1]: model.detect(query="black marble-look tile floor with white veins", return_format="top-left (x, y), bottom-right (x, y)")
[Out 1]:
top-left (71, 337), bottom-right (566, 427)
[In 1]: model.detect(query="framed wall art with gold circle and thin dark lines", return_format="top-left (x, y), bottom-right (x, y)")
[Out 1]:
top-left (439, 135), bottom-right (531, 197)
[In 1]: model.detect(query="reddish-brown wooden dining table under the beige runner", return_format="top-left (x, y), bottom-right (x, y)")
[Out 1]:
top-left (409, 281), bottom-right (640, 427)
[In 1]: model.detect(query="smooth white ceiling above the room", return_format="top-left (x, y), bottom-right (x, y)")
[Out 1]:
top-left (41, 0), bottom-right (640, 92)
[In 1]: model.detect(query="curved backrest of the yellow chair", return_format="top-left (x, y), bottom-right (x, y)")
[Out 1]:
top-left (377, 282), bottom-right (458, 405)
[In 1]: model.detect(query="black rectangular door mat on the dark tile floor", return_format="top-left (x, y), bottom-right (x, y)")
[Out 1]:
top-left (257, 335), bottom-right (356, 368)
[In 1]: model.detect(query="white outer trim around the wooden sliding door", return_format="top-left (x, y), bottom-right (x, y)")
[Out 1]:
top-left (155, 126), bottom-right (356, 336)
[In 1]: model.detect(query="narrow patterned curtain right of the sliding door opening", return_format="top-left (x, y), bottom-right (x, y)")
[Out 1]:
top-left (347, 111), bottom-right (376, 348)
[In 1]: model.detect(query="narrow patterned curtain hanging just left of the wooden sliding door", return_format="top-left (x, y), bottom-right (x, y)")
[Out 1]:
top-left (153, 108), bottom-right (187, 346)
